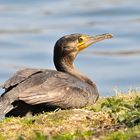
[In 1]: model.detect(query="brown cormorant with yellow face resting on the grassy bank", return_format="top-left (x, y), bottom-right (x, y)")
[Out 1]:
top-left (0, 34), bottom-right (113, 118)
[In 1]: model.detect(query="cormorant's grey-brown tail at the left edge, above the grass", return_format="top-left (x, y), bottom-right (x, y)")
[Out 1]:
top-left (0, 96), bottom-right (13, 120)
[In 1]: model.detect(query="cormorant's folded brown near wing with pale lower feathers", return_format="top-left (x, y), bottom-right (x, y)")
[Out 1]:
top-left (19, 72), bottom-right (88, 108)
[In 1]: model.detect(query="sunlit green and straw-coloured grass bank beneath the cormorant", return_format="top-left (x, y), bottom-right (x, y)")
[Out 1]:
top-left (0, 90), bottom-right (140, 140)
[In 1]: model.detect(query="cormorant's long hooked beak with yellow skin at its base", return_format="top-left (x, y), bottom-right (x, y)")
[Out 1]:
top-left (77, 33), bottom-right (113, 51)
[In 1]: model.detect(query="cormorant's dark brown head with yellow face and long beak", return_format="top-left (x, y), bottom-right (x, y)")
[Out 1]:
top-left (54, 33), bottom-right (113, 70)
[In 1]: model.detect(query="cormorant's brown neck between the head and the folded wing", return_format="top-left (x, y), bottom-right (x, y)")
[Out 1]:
top-left (54, 57), bottom-right (93, 85)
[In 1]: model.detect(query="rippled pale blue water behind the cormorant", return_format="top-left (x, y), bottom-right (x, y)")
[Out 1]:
top-left (0, 0), bottom-right (140, 96)
